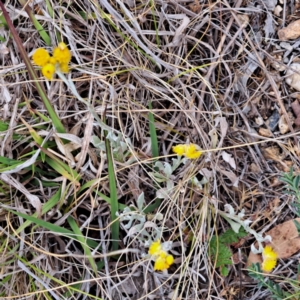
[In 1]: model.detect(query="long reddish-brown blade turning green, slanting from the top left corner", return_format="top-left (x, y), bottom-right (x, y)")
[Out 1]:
top-left (0, 1), bottom-right (66, 133)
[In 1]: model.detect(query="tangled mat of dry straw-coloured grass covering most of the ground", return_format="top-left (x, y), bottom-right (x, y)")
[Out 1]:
top-left (0, 0), bottom-right (299, 299)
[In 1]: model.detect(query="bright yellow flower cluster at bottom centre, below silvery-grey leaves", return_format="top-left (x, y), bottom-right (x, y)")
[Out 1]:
top-left (149, 241), bottom-right (174, 271)
